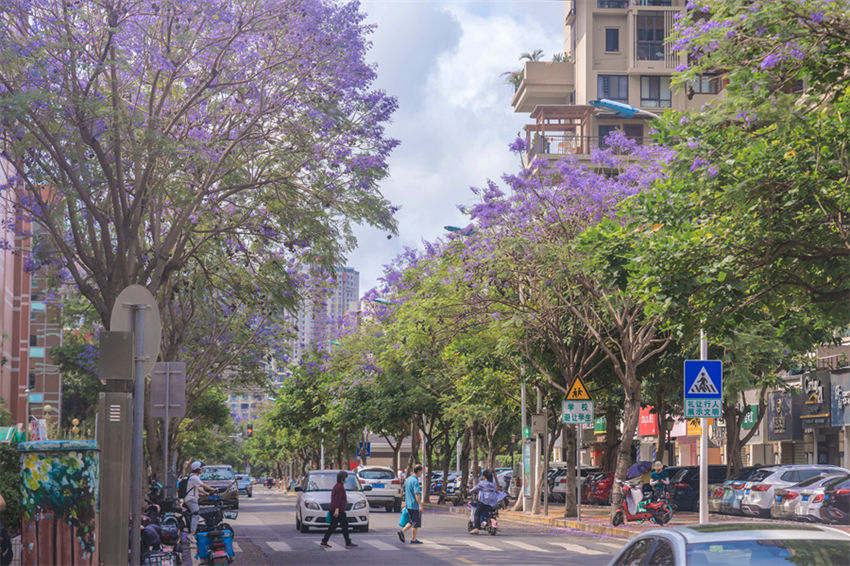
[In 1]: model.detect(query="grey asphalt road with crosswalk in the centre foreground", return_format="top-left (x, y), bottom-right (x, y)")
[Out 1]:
top-left (219, 486), bottom-right (624, 566)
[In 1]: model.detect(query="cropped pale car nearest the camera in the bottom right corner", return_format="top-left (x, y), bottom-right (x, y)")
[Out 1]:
top-left (609, 523), bottom-right (850, 566)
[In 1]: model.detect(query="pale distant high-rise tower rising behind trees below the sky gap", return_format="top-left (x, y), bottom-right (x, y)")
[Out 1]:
top-left (291, 267), bottom-right (360, 361)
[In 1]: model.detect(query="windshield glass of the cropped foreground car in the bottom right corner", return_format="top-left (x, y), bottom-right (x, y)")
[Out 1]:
top-left (687, 540), bottom-right (850, 566)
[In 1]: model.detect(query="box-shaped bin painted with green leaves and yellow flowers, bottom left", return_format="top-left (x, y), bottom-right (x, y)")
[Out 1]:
top-left (18, 440), bottom-right (100, 566)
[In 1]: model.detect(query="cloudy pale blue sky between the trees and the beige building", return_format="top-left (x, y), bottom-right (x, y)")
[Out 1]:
top-left (347, 0), bottom-right (564, 295)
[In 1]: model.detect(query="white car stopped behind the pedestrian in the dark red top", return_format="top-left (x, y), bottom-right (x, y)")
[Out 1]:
top-left (295, 470), bottom-right (371, 533)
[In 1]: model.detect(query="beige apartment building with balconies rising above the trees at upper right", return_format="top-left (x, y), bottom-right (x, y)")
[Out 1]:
top-left (511, 0), bottom-right (721, 159)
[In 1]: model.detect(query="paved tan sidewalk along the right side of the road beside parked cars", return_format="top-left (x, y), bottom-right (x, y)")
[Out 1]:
top-left (424, 503), bottom-right (850, 539)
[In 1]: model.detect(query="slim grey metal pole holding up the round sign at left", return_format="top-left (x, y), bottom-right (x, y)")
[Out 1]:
top-left (128, 304), bottom-right (146, 564)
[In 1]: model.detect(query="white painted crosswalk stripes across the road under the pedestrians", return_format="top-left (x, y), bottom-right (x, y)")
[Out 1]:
top-left (233, 535), bottom-right (622, 556)
